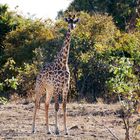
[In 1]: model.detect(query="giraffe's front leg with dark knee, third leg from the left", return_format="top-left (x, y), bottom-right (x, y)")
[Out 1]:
top-left (54, 95), bottom-right (59, 135)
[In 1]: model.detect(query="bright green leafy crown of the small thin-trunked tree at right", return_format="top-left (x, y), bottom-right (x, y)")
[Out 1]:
top-left (109, 57), bottom-right (139, 97)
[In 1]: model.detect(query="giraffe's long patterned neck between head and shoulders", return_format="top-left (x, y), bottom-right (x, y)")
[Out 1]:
top-left (55, 29), bottom-right (71, 67)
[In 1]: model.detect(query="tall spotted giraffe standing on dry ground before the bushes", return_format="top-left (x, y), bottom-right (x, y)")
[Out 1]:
top-left (32, 15), bottom-right (79, 135)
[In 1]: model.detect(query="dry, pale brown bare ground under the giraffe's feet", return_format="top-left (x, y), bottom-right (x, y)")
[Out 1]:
top-left (0, 103), bottom-right (140, 140)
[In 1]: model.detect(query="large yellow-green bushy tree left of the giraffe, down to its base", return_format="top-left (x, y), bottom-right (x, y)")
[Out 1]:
top-left (0, 11), bottom-right (54, 96)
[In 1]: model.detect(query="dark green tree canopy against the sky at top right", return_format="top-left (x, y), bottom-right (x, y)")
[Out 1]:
top-left (68, 0), bottom-right (140, 30)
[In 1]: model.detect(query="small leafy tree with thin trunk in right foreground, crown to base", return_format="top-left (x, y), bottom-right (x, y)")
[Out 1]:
top-left (108, 57), bottom-right (140, 140)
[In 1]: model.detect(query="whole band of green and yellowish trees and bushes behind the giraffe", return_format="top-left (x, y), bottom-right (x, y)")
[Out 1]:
top-left (0, 0), bottom-right (140, 102)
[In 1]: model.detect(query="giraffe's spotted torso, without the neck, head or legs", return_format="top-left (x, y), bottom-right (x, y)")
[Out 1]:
top-left (35, 63), bottom-right (70, 96)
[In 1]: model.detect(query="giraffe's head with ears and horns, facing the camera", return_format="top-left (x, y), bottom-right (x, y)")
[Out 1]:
top-left (65, 15), bottom-right (79, 30)
